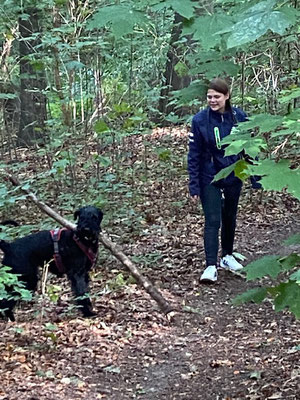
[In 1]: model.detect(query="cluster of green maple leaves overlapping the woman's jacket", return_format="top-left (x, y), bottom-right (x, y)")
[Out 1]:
top-left (214, 107), bottom-right (300, 199)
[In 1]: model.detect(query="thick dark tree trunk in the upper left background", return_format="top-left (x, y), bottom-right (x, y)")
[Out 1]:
top-left (18, 8), bottom-right (46, 146)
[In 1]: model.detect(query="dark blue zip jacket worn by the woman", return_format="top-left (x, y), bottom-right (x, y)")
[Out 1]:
top-left (188, 107), bottom-right (247, 196)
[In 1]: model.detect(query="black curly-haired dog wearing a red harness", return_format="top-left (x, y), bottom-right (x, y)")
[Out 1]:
top-left (0, 206), bottom-right (103, 321)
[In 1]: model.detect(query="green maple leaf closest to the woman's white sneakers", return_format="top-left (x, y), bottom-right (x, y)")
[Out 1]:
top-left (243, 255), bottom-right (281, 280)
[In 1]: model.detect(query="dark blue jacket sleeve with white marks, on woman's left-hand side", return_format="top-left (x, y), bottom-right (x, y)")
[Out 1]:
top-left (188, 117), bottom-right (202, 196)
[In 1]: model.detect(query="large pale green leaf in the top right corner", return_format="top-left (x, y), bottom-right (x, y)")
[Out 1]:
top-left (227, 0), bottom-right (293, 49)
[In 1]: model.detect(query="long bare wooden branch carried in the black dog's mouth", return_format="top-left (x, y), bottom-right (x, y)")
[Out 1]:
top-left (5, 172), bottom-right (174, 314)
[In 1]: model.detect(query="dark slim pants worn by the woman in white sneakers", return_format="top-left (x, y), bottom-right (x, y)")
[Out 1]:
top-left (200, 183), bottom-right (242, 266)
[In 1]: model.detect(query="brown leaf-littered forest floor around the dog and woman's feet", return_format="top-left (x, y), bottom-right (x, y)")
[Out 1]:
top-left (0, 127), bottom-right (300, 400)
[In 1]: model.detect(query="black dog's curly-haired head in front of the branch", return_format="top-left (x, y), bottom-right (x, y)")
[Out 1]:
top-left (74, 206), bottom-right (103, 243)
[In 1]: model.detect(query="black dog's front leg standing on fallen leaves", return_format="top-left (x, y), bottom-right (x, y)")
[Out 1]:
top-left (68, 273), bottom-right (96, 317)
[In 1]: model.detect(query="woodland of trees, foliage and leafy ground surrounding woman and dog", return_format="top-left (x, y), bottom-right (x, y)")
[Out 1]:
top-left (0, 0), bottom-right (300, 400)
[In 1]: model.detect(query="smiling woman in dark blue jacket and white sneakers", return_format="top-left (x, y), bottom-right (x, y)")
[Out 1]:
top-left (188, 78), bottom-right (247, 282)
